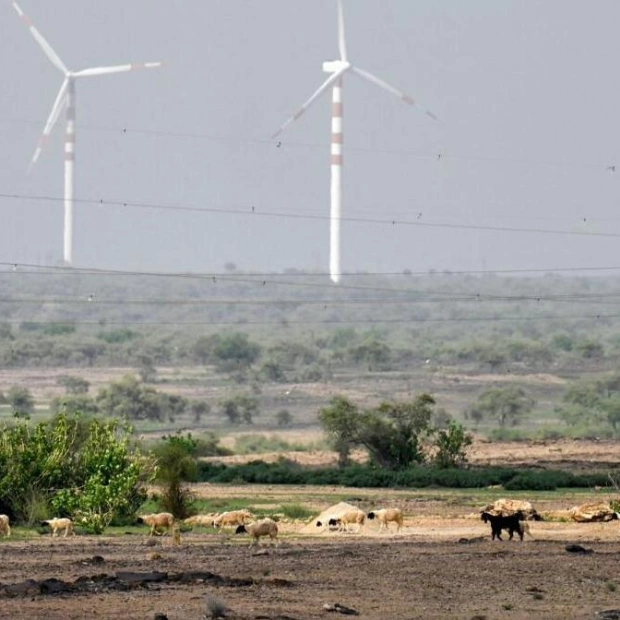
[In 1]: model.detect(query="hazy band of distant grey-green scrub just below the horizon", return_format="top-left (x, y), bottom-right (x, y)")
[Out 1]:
top-left (0, 269), bottom-right (620, 382)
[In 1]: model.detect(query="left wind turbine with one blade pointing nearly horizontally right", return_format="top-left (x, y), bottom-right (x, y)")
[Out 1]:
top-left (13, 2), bottom-right (162, 265)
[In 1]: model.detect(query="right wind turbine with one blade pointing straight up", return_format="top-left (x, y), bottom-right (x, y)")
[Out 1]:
top-left (272, 0), bottom-right (437, 283)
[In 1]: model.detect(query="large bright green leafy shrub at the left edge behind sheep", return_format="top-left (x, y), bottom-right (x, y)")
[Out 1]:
top-left (0, 414), bottom-right (152, 533)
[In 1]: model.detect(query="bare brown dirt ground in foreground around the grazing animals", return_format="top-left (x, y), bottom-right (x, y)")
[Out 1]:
top-left (0, 484), bottom-right (620, 620)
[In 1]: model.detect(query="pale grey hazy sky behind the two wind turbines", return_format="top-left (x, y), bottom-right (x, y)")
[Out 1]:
top-left (0, 0), bottom-right (620, 272)
